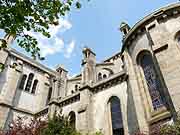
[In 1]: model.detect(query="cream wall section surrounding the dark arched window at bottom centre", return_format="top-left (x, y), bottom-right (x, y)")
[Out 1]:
top-left (92, 82), bottom-right (128, 135)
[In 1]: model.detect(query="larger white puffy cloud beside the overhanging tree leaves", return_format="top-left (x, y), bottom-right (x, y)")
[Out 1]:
top-left (24, 18), bottom-right (72, 57)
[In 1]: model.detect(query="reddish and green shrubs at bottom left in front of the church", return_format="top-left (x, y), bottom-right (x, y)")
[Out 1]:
top-left (0, 114), bottom-right (103, 135)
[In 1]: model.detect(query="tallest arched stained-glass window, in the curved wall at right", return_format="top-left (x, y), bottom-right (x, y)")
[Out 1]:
top-left (140, 53), bottom-right (164, 110)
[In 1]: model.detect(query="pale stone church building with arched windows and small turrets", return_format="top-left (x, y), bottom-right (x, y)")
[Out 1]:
top-left (0, 3), bottom-right (180, 135)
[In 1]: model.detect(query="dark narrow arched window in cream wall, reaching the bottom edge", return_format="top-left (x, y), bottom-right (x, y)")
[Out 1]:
top-left (109, 97), bottom-right (124, 135)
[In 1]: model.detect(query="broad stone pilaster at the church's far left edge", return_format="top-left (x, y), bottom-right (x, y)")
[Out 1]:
top-left (0, 61), bottom-right (22, 128)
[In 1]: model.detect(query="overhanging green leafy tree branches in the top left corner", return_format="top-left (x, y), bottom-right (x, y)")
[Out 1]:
top-left (0, 0), bottom-right (81, 59)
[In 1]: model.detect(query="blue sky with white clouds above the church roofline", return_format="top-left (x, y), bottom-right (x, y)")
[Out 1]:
top-left (1, 0), bottom-right (178, 76)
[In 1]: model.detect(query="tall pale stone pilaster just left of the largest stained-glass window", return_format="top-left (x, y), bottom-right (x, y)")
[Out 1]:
top-left (123, 49), bottom-right (149, 132)
